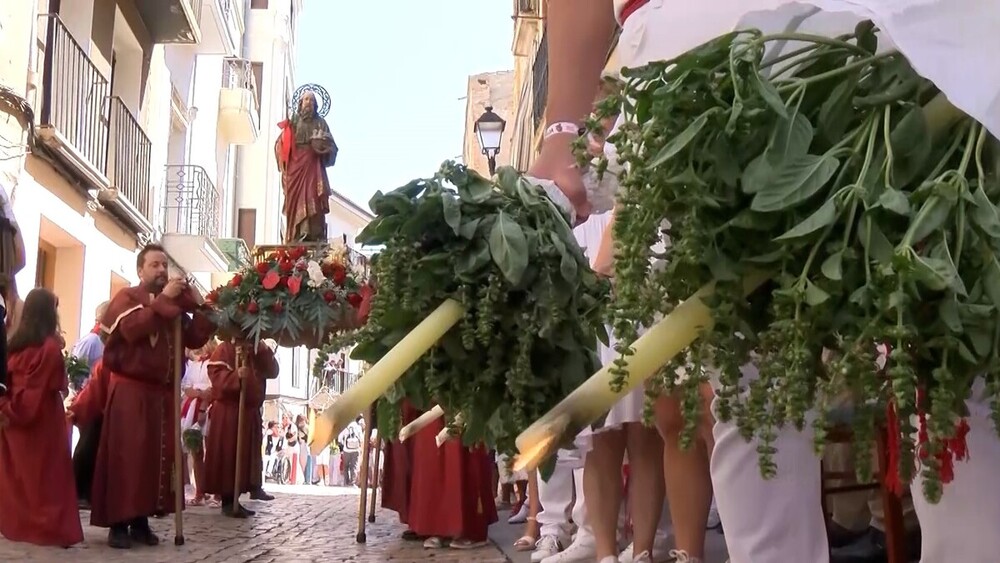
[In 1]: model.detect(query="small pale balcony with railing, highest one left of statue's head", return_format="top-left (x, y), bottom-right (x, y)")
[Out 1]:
top-left (219, 57), bottom-right (260, 145)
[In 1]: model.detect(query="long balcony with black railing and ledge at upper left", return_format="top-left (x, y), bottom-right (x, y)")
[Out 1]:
top-left (36, 14), bottom-right (153, 235)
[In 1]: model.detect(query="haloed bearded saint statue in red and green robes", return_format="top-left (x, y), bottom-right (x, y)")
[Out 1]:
top-left (274, 85), bottom-right (337, 244)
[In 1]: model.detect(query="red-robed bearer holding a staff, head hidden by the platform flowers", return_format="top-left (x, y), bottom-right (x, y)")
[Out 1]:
top-left (204, 342), bottom-right (278, 518)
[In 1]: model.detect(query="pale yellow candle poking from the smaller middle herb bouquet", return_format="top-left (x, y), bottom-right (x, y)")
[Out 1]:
top-left (312, 299), bottom-right (465, 454)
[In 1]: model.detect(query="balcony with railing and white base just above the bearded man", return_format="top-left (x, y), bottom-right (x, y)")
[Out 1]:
top-left (161, 164), bottom-right (229, 272)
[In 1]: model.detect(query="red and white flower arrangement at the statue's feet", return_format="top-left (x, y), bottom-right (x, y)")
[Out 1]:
top-left (205, 244), bottom-right (365, 347)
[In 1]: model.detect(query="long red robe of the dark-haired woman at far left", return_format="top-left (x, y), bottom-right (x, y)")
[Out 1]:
top-left (0, 337), bottom-right (83, 547)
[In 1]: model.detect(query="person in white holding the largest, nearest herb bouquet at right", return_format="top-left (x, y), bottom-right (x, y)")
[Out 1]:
top-left (529, 0), bottom-right (1000, 563)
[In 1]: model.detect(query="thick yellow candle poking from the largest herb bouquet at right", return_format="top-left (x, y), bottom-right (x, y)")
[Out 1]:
top-left (514, 274), bottom-right (769, 470)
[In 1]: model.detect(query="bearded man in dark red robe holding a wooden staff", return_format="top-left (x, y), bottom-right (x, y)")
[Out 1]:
top-left (90, 244), bottom-right (215, 549)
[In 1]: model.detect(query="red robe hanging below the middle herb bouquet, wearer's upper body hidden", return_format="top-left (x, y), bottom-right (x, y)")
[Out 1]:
top-left (406, 418), bottom-right (497, 542)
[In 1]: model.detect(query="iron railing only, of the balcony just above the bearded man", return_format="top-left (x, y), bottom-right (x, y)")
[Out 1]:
top-left (163, 164), bottom-right (222, 239)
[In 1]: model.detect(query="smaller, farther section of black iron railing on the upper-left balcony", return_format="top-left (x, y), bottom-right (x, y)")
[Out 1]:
top-left (108, 96), bottom-right (153, 223)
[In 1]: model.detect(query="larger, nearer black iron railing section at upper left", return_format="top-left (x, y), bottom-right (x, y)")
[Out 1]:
top-left (39, 14), bottom-right (111, 173)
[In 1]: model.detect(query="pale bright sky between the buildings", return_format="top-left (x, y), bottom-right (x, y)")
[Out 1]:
top-left (295, 0), bottom-right (514, 213)
